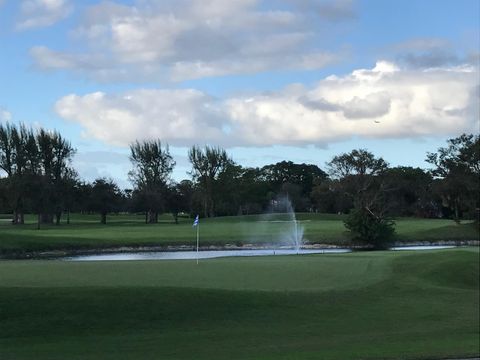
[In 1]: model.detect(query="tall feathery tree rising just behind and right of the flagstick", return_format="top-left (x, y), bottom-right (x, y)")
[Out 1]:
top-left (188, 146), bottom-right (234, 217)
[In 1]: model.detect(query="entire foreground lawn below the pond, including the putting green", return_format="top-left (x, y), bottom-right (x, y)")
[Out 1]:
top-left (0, 248), bottom-right (480, 360)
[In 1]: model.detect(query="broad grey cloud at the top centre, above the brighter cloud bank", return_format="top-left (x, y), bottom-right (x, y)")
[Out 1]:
top-left (31, 0), bottom-right (351, 81)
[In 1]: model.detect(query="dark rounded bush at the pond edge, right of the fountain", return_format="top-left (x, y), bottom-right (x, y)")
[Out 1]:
top-left (344, 209), bottom-right (395, 249)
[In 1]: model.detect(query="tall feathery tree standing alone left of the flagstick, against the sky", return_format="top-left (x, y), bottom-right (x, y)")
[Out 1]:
top-left (128, 140), bottom-right (175, 223)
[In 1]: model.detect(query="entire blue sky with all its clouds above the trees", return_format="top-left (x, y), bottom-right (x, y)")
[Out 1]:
top-left (0, 0), bottom-right (480, 188)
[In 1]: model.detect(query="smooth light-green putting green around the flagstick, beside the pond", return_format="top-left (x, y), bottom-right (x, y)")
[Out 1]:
top-left (0, 252), bottom-right (394, 291)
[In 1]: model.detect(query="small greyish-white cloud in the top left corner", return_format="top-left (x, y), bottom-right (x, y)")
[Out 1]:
top-left (16, 0), bottom-right (73, 30)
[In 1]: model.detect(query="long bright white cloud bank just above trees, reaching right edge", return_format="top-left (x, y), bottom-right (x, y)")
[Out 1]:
top-left (56, 62), bottom-right (479, 146)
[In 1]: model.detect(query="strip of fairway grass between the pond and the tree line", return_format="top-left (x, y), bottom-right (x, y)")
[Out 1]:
top-left (0, 213), bottom-right (479, 255)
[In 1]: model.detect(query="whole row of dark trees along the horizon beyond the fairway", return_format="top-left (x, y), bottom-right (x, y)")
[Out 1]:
top-left (0, 123), bottom-right (480, 227)
